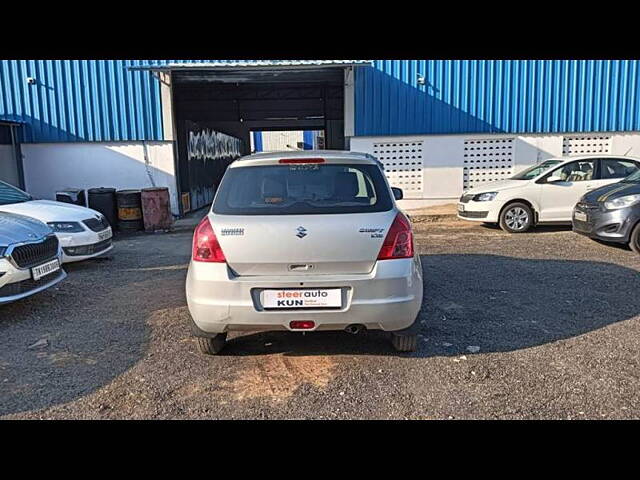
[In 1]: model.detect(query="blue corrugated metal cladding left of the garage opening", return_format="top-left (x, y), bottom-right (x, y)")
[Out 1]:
top-left (0, 60), bottom-right (168, 142)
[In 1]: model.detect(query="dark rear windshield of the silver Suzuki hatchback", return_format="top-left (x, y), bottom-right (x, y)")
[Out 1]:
top-left (213, 164), bottom-right (393, 215)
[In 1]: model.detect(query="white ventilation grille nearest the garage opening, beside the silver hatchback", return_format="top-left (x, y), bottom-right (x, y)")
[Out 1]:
top-left (373, 141), bottom-right (423, 197)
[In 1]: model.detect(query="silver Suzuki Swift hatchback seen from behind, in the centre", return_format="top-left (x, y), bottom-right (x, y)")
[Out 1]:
top-left (186, 150), bottom-right (423, 354)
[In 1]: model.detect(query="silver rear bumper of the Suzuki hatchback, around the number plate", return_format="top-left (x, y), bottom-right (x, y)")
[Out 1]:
top-left (186, 258), bottom-right (423, 335)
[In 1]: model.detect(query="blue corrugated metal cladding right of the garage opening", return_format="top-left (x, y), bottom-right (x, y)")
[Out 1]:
top-left (355, 60), bottom-right (640, 135)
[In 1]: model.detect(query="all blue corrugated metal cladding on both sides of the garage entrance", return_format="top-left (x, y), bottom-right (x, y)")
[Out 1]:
top-left (0, 60), bottom-right (640, 142)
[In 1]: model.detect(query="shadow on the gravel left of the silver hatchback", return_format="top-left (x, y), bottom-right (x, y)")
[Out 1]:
top-left (0, 234), bottom-right (189, 416)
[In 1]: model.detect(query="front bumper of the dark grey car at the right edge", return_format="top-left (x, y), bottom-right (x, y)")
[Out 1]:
top-left (572, 205), bottom-right (640, 244)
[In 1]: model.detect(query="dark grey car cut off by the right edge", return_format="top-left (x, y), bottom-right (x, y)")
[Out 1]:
top-left (573, 171), bottom-right (640, 253)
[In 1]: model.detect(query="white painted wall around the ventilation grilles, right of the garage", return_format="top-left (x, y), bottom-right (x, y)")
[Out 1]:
top-left (349, 132), bottom-right (640, 208)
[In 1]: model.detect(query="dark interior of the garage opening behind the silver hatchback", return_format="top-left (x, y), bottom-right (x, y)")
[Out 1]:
top-left (171, 68), bottom-right (345, 210)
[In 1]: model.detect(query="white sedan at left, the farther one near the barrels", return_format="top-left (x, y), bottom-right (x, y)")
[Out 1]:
top-left (0, 182), bottom-right (113, 263)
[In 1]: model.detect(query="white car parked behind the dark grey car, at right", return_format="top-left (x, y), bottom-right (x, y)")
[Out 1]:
top-left (458, 155), bottom-right (640, 233)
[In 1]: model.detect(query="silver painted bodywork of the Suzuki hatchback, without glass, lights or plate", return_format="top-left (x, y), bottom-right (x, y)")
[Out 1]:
top-left (186, 151), bottom-right (423, 334)
